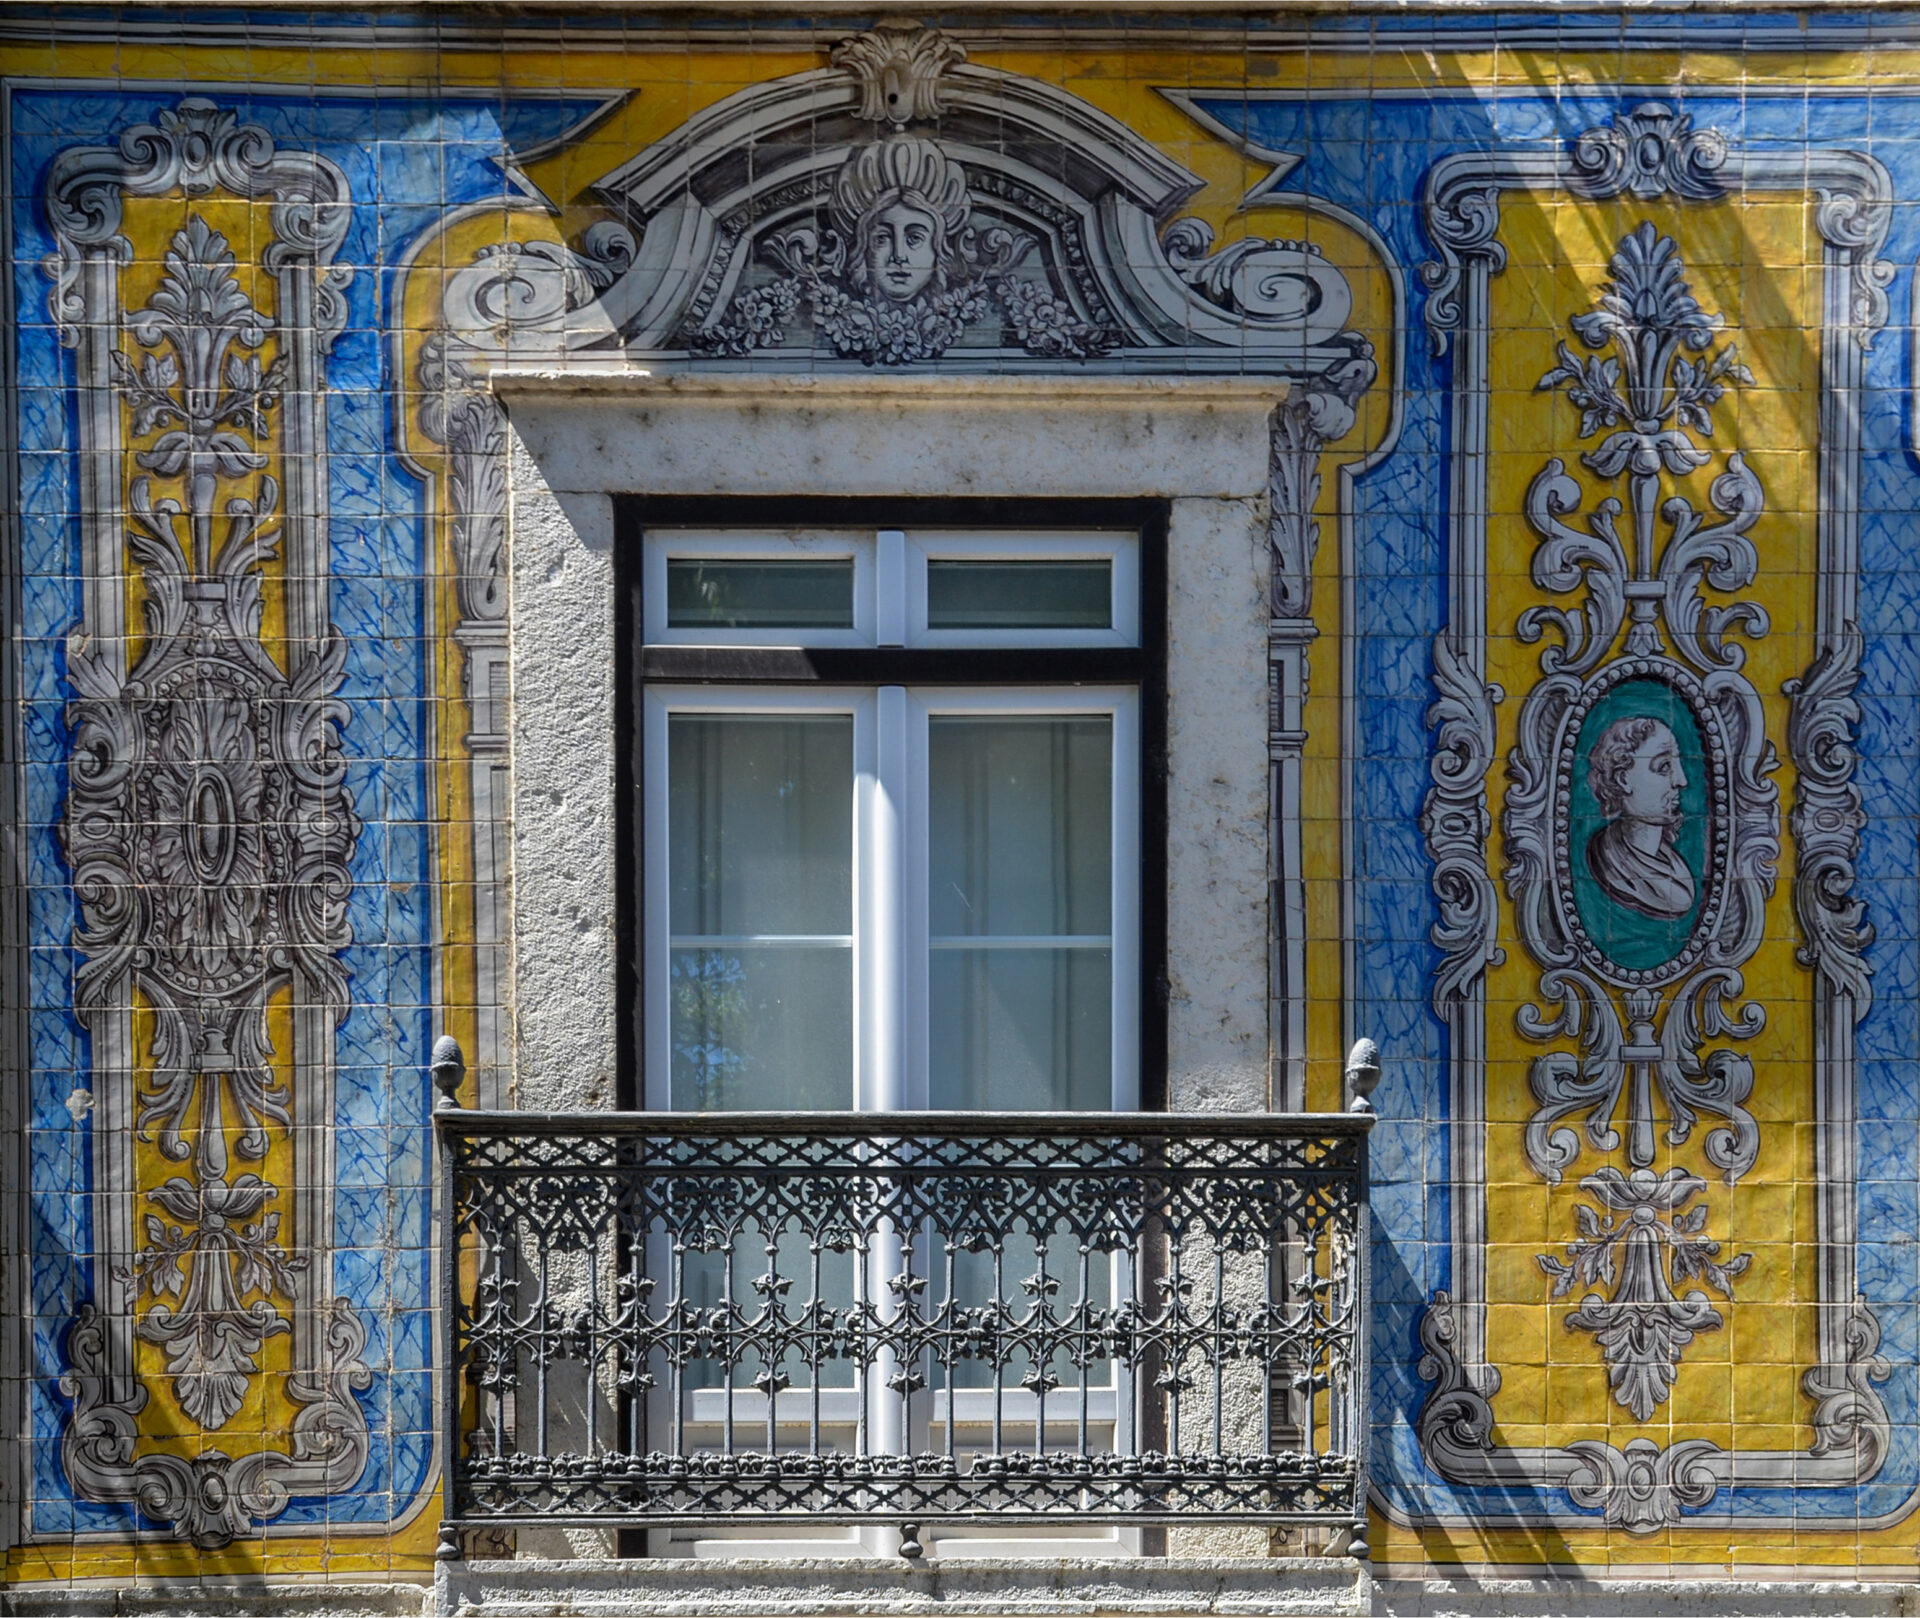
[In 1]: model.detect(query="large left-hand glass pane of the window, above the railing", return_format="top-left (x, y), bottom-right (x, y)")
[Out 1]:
top-left (666, 714), bottom-right (852, 1111)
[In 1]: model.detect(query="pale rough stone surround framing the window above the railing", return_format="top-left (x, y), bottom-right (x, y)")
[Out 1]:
top-left (492, 367), bottom-right (1286, 1111)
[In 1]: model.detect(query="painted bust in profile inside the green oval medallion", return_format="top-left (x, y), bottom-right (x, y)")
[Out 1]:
top-left (1586, 718), bottom-right (1693, 921)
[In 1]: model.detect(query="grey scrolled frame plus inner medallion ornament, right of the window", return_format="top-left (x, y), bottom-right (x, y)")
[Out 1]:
top-left (1419, 104), bottom-right (1891, 1534)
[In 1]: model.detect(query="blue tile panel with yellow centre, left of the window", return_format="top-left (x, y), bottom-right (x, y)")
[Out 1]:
top-left (10, 86), bottom-right (606, 1551)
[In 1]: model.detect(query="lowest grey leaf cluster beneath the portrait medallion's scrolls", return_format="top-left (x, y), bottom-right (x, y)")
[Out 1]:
top-left (1540, 1169), bottom-right (1751, 1420)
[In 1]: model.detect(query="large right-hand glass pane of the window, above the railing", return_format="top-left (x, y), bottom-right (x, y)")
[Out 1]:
top-left (927, 718), bottom-right (1114, 1109)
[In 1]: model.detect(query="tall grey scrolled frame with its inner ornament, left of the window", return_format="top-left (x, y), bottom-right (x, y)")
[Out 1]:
top-left (46, 98), bottom-right (371, 1549)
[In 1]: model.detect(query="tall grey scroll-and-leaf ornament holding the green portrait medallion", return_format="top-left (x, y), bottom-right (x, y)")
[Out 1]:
top-left (1503, 223), bottom-right (1780, 1420)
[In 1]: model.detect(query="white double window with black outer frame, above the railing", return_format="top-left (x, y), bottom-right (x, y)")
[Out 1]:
top-left (620, 499), bottom-right (1165, 1111)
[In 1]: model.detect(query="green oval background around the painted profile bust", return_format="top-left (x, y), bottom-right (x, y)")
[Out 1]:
top-left (1567, 679), bottom-right (1709, 971)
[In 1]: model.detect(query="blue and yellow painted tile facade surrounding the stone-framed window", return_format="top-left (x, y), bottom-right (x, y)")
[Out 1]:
top-left (0, 8), bottom-right (1920, 1585)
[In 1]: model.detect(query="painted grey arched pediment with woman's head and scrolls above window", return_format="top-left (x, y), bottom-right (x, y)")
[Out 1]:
top-left (445, 27), bottom-right (1373, 393)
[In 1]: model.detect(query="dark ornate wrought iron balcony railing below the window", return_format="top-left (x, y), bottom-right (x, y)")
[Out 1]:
top-left (436, 1106), bottom-right (1371, 1555)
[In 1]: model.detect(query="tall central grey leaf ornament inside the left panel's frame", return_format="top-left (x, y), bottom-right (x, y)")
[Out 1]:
top-left (65, 215), bottom-right (359, 1430)
